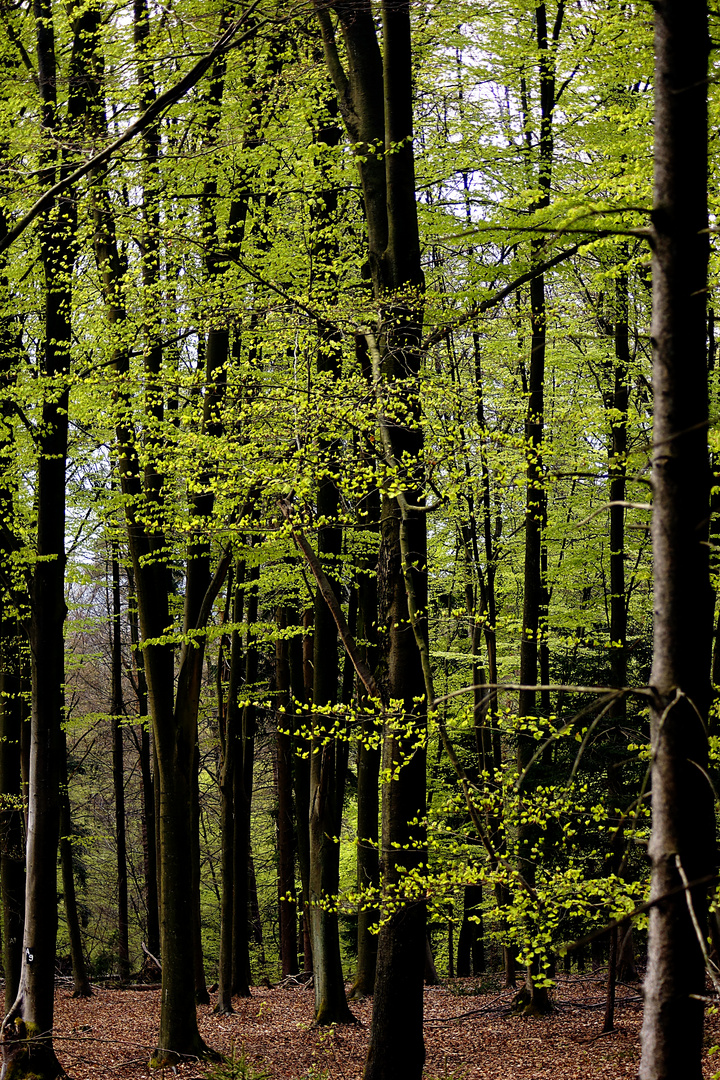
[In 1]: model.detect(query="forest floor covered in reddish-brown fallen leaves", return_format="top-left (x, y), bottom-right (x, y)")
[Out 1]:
top-left (50, 975), bottom-right (720, 1080)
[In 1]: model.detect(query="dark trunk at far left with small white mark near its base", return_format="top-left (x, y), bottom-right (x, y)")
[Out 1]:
top-left (2, 0), bottom-right (85, 1080)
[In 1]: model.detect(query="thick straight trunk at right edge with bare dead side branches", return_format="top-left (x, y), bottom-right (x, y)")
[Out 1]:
top-left (640, 0), bottom-right (716, 1080)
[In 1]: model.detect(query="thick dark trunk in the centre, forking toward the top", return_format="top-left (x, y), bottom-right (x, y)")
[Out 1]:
top-left (316, 0), bottom-right (427, 1080)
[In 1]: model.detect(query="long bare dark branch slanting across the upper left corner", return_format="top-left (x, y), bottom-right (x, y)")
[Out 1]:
top-left (0, 0), bottom-right (264, 253)
